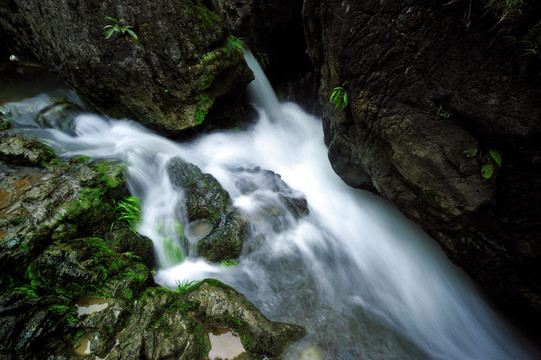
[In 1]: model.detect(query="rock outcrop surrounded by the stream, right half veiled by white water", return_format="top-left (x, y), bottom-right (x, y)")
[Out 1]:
top-left (167, 158), bottom-right (309, 262)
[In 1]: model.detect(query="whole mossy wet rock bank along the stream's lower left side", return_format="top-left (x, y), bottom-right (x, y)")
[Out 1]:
top-left (0, 136), bottom-right (304, 360)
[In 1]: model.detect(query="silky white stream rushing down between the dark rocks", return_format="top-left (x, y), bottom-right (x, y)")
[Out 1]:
top-left (2, 54), bottom-right (538, 360)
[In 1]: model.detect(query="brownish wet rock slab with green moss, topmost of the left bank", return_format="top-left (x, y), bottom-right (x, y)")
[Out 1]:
top-left (0, 140), bottom-right (127, 271)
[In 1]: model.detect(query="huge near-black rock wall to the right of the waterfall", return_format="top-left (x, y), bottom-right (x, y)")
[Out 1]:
top-left (303, 0), bottom-right (541, 330)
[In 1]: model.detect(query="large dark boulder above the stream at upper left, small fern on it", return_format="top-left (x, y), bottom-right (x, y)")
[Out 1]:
top-left (0, 0), bottom-right (253, 132)
